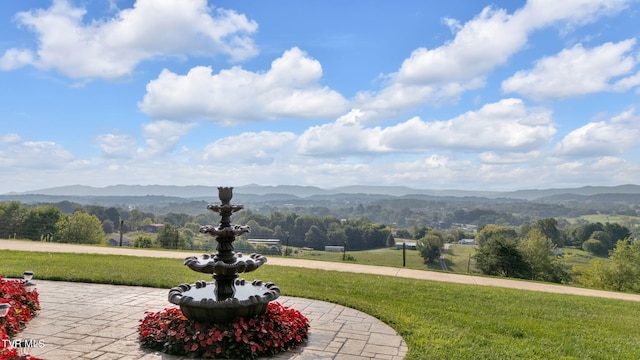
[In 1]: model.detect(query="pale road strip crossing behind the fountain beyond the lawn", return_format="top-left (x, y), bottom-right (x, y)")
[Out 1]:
top-left (0, 239), bottom-right (640, 302)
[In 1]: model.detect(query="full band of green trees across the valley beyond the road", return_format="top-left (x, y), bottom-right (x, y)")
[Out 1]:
top-left (0, 201), bottom-right (640, 292)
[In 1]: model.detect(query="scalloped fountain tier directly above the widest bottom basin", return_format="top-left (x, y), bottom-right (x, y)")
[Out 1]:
top-left (184, 252), bottom-right (267, 275)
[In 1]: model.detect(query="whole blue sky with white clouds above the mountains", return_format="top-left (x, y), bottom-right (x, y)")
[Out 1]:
top-left (0, 0), bottom-right (640, 193)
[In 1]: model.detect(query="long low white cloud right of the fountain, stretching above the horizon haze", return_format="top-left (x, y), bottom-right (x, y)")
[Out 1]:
top-left (298, 99), bottom-right (556, 156)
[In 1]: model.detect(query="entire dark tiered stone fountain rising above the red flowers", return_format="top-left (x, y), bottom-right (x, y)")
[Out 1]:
top-left (169, 187), bottom-right (280, 324)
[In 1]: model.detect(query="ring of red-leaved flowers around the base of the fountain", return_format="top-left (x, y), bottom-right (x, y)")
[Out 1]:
top-left (138, 302), bottom-right (309, 359)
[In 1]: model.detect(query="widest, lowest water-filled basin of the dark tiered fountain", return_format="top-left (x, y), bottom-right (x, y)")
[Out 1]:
top-left (169, 279), bottom-right (280, 323)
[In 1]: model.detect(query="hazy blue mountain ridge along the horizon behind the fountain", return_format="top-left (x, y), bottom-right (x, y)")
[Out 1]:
top-left (3, 184), bottom-right (640, 200)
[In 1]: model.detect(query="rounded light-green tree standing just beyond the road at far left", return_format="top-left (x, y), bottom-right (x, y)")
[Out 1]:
top-left (54, 211), bottom-right (106, 244)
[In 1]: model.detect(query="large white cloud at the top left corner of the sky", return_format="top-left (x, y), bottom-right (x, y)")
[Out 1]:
top-left (0, 0), bottom-right (257, 79)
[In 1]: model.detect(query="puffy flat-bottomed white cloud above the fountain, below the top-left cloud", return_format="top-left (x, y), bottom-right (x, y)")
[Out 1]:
top-left (138, 48), bottom-right (347, 126)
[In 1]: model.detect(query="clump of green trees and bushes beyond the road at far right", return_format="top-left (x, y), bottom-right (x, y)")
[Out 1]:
top-left (462, 218), bottom-right (640, 292)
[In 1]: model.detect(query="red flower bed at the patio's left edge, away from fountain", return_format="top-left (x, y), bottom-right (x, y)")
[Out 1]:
top-left (0, 276), bottom-right (40, 360)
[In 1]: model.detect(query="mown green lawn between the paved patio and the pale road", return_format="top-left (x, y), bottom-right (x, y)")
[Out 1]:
top-left (0, 251), bottom-right (640, 360)
